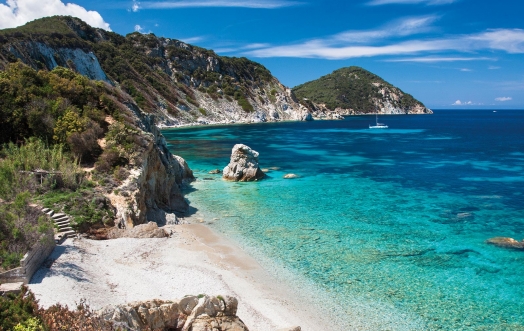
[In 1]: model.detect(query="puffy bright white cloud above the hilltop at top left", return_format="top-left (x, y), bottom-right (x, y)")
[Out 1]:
top-left (0, 0), bottom-right (111, 31)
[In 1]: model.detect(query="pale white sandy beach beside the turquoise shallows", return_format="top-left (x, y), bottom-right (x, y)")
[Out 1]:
top-left (29, 224), bottom-right (328, 331)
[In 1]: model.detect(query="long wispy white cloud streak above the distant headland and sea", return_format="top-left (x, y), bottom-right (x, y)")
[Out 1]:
top-left (246, 16), bottom-right (524, 62)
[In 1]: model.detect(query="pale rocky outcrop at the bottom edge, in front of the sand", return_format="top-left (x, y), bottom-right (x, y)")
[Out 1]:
top-left (98, 295), bottom-right (248, 331)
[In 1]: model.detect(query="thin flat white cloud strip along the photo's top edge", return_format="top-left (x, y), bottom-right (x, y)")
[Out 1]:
top-left (139, 0), bottom-right (302, 9)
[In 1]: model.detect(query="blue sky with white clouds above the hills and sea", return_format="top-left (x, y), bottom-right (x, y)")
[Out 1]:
top-left (0, 0), bottom-right (524, 109)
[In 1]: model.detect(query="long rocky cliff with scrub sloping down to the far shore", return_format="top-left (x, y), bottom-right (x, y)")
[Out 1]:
top-left (0, 16), bottom-right (311, 126)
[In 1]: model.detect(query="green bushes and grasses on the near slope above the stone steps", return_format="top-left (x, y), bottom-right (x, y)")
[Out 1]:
top-left (0, 62), bottom-right (143, 237)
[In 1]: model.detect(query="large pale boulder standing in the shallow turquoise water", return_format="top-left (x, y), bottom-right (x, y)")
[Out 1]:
top-left (222, 144), bottom-right (265, 182)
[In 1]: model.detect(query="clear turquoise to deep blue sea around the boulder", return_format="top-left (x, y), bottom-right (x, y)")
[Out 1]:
top-left (163, 110), bottom-right (524, 331)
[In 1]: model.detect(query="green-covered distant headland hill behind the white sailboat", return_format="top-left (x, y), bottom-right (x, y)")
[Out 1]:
top-left (293, 67), bottom-right (421, 113)
